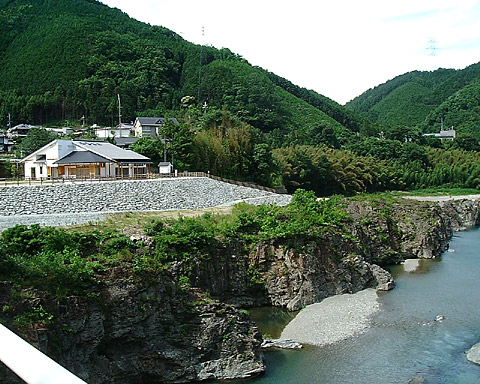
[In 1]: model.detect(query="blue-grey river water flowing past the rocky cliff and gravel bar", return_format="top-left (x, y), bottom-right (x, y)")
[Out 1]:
top-left (244, 229), bottom-right (480, 384)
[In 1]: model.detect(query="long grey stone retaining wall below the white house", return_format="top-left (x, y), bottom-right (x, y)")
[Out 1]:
top-left (0, 177), bottom-right (290, 216)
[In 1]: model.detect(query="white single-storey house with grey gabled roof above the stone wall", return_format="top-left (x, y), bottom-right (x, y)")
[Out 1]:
top-left (22, 139), bottom-right (152, 179)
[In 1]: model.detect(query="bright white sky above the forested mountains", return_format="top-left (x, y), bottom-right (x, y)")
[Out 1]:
top-left (101, 0), bottom-right (480, 104)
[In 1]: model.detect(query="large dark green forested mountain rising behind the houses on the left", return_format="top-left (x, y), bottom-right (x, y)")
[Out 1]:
top-left (0, 0), bottom-right (368, 144)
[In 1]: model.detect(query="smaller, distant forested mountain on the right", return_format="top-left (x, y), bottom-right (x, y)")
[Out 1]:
top-left (346, 63), bottom-right (480, 139)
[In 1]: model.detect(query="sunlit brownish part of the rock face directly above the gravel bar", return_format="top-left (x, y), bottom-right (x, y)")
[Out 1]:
top-left (253, 235), bottom-right (387, 311)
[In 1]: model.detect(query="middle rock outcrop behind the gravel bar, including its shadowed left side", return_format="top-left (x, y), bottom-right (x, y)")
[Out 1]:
top-left (186, 231), bottom-right (394, 311)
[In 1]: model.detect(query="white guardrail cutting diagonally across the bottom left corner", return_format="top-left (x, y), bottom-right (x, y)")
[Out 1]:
top-left (0, 324), bottom-right (86, 384)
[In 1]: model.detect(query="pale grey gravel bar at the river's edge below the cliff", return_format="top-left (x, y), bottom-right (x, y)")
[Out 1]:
top-left (280, 289), bottom-right (380, 346)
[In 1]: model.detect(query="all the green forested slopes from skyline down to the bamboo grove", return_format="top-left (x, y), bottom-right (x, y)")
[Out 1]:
top-left (0, 0), bottom-right (480, 195)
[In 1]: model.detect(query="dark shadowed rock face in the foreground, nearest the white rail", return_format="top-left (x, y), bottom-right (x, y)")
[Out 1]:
top-left (0, 272), bottom-right (264, 384)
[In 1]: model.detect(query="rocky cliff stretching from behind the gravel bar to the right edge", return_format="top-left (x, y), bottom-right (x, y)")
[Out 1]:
top-left (188, 199), bottom-right (480, 310)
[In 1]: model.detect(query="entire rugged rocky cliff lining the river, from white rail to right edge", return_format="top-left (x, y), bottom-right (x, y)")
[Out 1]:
top-left (0, 199), bottom-right (480, 384)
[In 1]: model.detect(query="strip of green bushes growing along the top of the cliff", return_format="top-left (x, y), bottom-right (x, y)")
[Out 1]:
top-left (0, 190), bottom-right (348, 296)
